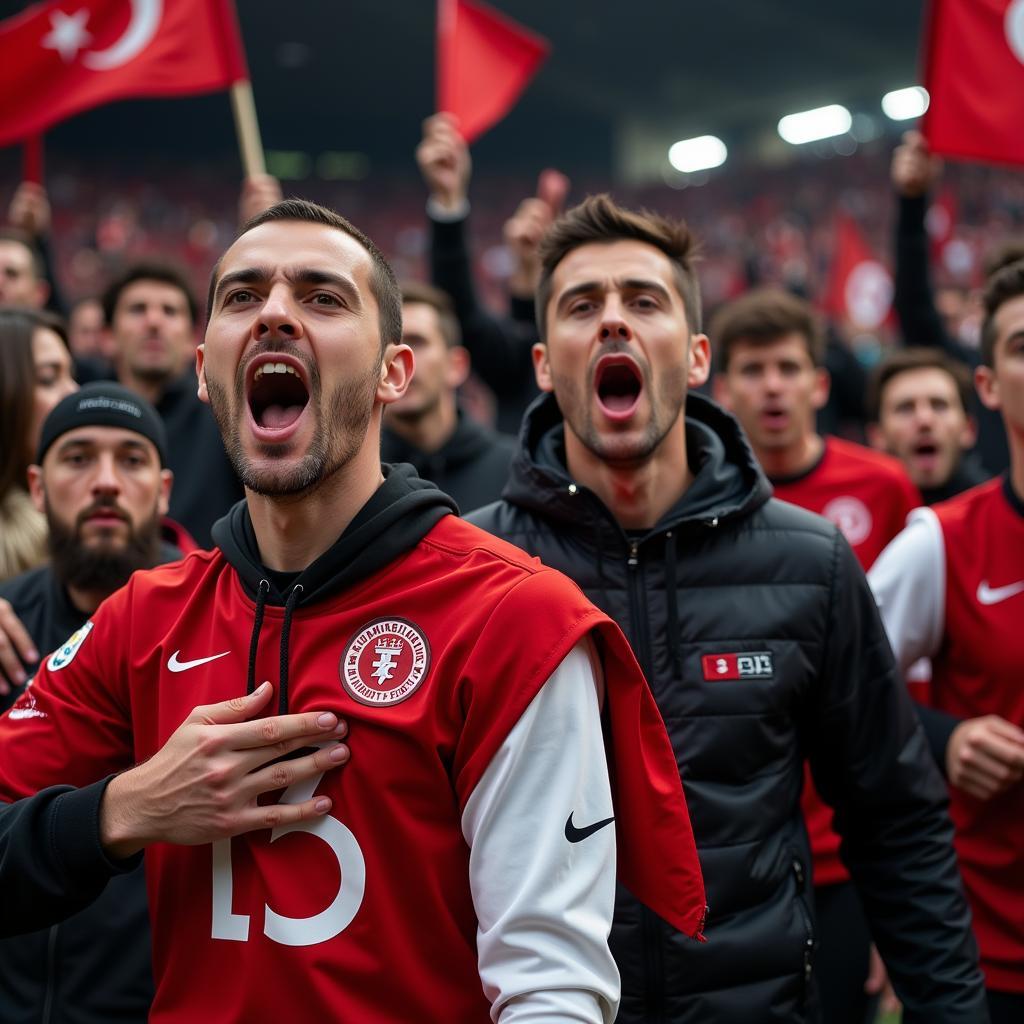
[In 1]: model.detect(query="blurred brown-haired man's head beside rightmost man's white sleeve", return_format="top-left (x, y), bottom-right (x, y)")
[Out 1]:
top-left (867, 348), bottom-right (991, 505)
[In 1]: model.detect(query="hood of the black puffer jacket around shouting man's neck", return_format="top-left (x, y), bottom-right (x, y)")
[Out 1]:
top-left (502, 392), bottom-right (771, 532)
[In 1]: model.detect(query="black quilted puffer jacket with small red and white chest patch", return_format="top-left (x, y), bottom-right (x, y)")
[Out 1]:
top-left (469, 395), bottom-right (987, 1024)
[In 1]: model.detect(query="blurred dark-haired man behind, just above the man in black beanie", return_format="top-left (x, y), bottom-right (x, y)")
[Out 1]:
top-left (102, 262), bottom-right (243, 547)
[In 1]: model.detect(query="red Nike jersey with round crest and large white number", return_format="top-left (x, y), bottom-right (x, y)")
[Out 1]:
top-left (0, 516), bottom-right (705, 1024)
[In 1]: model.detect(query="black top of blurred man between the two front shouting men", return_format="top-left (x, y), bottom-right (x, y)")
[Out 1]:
top-left (381, 410), bottom-right (517, 512)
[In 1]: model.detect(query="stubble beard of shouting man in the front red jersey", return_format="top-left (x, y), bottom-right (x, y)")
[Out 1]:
top-left (206, 359), bottom-right (381, 498)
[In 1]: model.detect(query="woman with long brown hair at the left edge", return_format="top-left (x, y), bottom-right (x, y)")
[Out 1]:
top-left (0, 309), bottom-right (78, 581)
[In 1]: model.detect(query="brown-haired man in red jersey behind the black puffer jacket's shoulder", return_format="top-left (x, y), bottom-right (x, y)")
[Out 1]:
top-left (711, 289), bottom-right (921, 1024)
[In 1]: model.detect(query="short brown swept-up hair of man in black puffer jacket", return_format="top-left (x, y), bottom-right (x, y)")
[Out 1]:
top-left (537, 193), bottom-right (700, 341)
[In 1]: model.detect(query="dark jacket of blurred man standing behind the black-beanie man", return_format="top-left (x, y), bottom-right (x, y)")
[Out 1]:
top-left (156, 370), bottom-right (245, 548)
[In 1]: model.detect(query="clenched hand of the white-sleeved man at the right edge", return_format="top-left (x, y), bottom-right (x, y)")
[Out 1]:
top-left (946, 715), bottom-right (1024, 800)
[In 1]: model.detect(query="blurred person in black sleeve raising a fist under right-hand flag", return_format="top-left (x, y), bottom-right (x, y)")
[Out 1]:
top-left (891, 131), bottom-right (1010, 473)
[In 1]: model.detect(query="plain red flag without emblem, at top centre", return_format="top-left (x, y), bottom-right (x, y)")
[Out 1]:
top-left (437, 0), bottom-right (551, 142)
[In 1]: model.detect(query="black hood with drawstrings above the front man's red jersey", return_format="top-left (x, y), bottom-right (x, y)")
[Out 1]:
top-left (213, 465), bottom-right (458, 715)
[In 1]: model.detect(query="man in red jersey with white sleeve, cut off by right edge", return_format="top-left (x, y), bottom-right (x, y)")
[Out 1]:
top-left (870, 262), bottom-right (1024, 1024)
